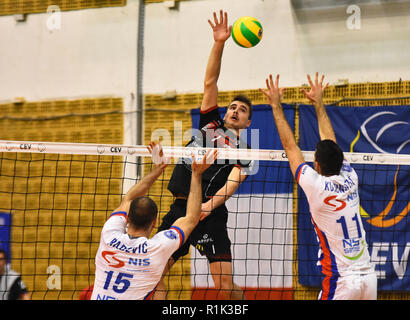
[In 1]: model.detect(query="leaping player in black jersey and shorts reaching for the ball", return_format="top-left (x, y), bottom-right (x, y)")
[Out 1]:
top-left (154, 10), bottom-right (252, 299)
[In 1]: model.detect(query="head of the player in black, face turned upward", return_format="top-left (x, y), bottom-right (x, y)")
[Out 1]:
top-left (224, 94), bottom-right (252, 129)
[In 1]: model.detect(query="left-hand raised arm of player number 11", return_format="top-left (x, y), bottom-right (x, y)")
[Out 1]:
top-left (259, 75), bottom-right (305, 176)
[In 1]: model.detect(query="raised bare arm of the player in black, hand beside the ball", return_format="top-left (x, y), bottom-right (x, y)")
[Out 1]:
top-left (201, 10), bottom-right (232, 112)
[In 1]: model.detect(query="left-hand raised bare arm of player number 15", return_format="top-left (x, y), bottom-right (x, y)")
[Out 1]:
top-left (115, 142), bottom-right (169, 212)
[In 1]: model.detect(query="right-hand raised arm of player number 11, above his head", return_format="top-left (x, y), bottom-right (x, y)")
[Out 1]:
top-left (302, 72), bottom-right (337, 143)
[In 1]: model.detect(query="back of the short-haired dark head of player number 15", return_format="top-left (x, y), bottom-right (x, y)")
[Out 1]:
top-left (128, 197), bottom-right (158, 230)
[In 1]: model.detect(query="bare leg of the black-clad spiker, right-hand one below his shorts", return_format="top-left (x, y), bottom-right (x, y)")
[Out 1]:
top-left (209, 261), bottom-right (245, 300)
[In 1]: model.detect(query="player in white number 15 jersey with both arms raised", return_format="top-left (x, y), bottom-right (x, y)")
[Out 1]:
top-left (91, 143), bottom-right (217, 300)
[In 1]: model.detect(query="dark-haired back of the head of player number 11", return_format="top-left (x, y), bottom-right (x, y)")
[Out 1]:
top-left (315, 140), bottom-right (344, 176)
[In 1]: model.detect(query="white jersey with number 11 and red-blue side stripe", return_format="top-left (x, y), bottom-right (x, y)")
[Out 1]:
top-left (295, 160), bottom-right (374, 277)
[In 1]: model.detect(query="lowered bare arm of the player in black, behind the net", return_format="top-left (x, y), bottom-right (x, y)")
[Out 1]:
top-left (200, 167), bottom-right (247, 220)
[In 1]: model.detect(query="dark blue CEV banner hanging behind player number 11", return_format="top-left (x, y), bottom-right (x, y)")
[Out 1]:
top-left (298, 105), bottom-right (410, 291)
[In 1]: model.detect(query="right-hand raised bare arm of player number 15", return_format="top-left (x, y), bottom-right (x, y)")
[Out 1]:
top-left (173, 151), bottom-right (218, 239)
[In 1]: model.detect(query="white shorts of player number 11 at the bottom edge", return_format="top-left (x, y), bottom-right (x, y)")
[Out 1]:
top-left (319, 272), bottom-right (377, 300)
